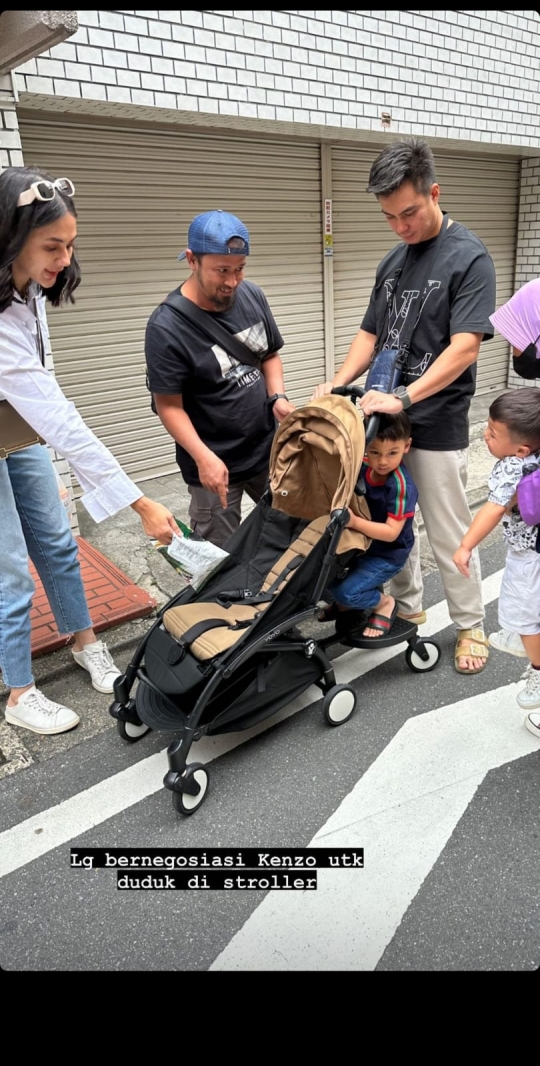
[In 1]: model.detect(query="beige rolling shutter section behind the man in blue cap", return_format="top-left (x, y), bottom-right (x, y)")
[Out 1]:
top-left (20, 114), bottom-right (325, 481)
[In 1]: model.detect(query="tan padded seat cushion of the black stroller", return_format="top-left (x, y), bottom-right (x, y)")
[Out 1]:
top-left (163, 515), bottom-right (330, 661)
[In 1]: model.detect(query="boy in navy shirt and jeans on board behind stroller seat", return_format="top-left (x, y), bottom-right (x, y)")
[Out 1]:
top-left (318, 411), bottom-right (419, 637)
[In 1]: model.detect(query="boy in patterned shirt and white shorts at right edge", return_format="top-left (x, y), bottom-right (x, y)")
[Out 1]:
top-left (454, 388), bottom-right (540, 739)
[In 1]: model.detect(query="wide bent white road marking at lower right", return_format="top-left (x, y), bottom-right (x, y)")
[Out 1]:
top-left (211, 683), bottom-right (538, 970)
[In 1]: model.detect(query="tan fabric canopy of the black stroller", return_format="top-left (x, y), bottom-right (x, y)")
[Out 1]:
top-left (269, 394), bottom-right (371, 552)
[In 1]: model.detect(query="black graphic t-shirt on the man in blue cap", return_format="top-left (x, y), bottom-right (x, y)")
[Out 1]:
top-left (145, 281), bottom-right (283, 485)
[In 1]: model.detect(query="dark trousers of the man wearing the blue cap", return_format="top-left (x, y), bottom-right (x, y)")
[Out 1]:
top-left (187, 468), bottom-right (268, 548)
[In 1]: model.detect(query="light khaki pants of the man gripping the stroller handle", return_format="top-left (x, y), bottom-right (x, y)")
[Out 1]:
top-left (388, 448), bottom-right (485, 629)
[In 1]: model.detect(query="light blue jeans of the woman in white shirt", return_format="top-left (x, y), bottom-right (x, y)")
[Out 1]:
top-left (0, 445), bottom-right (92, 689)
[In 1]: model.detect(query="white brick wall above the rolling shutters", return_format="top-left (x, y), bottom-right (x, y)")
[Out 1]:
top-left (11, 11), bottom-right (540, 147)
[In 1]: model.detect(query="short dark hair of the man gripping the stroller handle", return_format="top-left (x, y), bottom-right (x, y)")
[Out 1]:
top-left (366, 138), bottom-right (437, 196)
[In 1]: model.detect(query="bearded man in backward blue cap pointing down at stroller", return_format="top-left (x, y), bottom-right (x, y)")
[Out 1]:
top-left (145, 211), bottom-right (294, 546)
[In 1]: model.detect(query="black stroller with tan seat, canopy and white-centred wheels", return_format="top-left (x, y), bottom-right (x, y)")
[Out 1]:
top-left (110, 386), bottom-right (440, 814)
